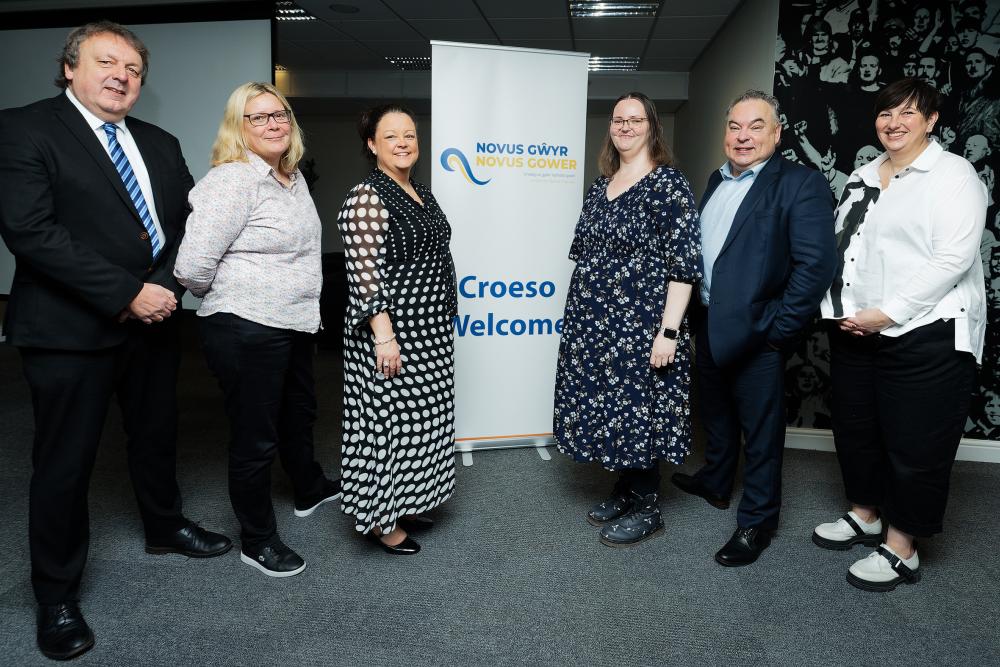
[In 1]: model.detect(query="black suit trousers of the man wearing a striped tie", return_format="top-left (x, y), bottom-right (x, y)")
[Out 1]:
top-left (20, 319), bottom-right (187, 604)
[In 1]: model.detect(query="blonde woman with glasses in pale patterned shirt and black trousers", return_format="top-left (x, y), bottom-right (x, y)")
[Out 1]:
top-left (174, 83), bottom-right (340, 577)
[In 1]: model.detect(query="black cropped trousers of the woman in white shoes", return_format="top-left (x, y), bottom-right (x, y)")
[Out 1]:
top-left (830, 320), bottom-right (976, 537)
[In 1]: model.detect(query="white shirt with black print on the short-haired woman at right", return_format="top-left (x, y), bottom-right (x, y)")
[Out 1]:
top-left (820, 141), bottom-right (987, 361)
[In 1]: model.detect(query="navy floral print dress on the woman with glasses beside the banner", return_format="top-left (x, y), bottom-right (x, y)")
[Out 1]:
top-left (553, 166), bottom-right (701, 470)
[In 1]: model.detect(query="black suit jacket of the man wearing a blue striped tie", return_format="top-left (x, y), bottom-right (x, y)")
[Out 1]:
top-left (0, 94), bottom-right (194, 350)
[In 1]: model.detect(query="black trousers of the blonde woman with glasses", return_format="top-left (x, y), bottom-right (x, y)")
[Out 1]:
top-left (201, 313), bottom-right (326, 548)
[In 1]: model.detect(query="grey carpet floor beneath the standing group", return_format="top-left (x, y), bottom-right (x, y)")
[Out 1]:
top-left (0, 320), bottom-right (1000, 666)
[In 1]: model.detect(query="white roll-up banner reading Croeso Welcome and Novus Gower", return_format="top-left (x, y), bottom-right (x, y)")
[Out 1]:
top-left (431, 41), bottom-right (588, 451)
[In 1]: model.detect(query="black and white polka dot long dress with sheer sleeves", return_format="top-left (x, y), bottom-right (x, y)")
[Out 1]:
top-left (339, 169), bottom-right (457, 533)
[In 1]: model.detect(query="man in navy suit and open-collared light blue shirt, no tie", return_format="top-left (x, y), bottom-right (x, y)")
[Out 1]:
top-left (672, 90), bottom-right (837, 566)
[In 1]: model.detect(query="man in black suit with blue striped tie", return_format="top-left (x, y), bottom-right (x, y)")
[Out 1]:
top-left (0, 22), bottom-right (232, 659)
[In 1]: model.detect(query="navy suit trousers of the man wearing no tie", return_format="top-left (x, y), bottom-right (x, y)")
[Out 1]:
top-left (694, 315), bottom-right (785, 530)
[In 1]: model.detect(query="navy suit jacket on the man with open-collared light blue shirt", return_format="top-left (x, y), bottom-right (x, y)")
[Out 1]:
top-left (700, 154), bottom-right (837, 366)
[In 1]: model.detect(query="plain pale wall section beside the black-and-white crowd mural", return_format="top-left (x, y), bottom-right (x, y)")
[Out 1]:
top-left (676, 0), bottom-right (778, 198)
